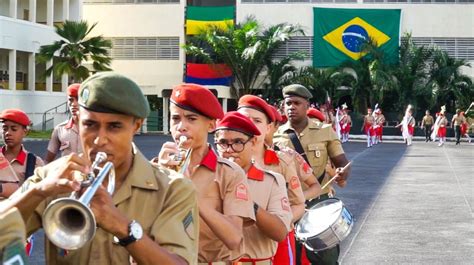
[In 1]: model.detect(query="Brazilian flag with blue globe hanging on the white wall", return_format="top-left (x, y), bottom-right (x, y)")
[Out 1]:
top-left (313, 7), bottom-right (401, 67)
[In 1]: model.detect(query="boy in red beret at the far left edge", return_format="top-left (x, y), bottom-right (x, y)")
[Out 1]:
top-left (0, 109), bottom-right (44, 199)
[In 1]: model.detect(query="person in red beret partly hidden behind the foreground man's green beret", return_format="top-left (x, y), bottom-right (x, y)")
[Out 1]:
top-left (45, 84), bottom-right (82, 163)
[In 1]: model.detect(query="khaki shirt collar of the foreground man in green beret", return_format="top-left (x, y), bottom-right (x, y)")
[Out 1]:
top-left (113, 144), bottom-right (158, 205)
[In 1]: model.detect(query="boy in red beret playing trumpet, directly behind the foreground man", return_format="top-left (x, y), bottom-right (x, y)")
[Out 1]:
top-left (155, 84), bottom-right (255, 264)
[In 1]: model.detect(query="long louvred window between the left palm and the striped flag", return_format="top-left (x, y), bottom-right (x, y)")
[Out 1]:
top-left (108, 37), bottom-right (179, 60)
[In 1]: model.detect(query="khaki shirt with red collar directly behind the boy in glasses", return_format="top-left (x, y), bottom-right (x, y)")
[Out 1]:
top-left (262, 149), bottom-right (305, 208)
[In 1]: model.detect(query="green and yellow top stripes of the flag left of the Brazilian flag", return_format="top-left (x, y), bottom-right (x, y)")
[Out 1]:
top-left (186, 6), bottom-right (235, 35)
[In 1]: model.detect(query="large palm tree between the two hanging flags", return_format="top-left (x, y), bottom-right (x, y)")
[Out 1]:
top-left (184, 17), bottom-right (304, 98)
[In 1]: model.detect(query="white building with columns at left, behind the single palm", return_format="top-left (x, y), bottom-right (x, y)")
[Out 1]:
top-left (0, 0), bottom-right (82, 127)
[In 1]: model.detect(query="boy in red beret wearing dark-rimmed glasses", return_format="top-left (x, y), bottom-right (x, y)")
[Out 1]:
top-left (215, 111), bottom-right (292, 264)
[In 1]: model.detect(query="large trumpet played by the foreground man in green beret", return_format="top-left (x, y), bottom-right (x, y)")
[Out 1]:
top-left (43, 152), bottom-right (115, 250)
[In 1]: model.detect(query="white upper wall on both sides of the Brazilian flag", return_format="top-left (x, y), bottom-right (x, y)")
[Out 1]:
top-left (237, 4), bottom-right (474, 37)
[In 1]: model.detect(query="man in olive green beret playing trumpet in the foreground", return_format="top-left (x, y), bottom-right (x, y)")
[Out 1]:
top-left (13, 72), bottom-right (198, 265)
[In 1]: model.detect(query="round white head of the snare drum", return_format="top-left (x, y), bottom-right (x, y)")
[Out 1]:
top-left (296, 198), bottom-right (343, 239)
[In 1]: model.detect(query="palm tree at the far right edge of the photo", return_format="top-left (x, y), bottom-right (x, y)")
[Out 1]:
top-left (429, 49), bottom-right (474, 112)
